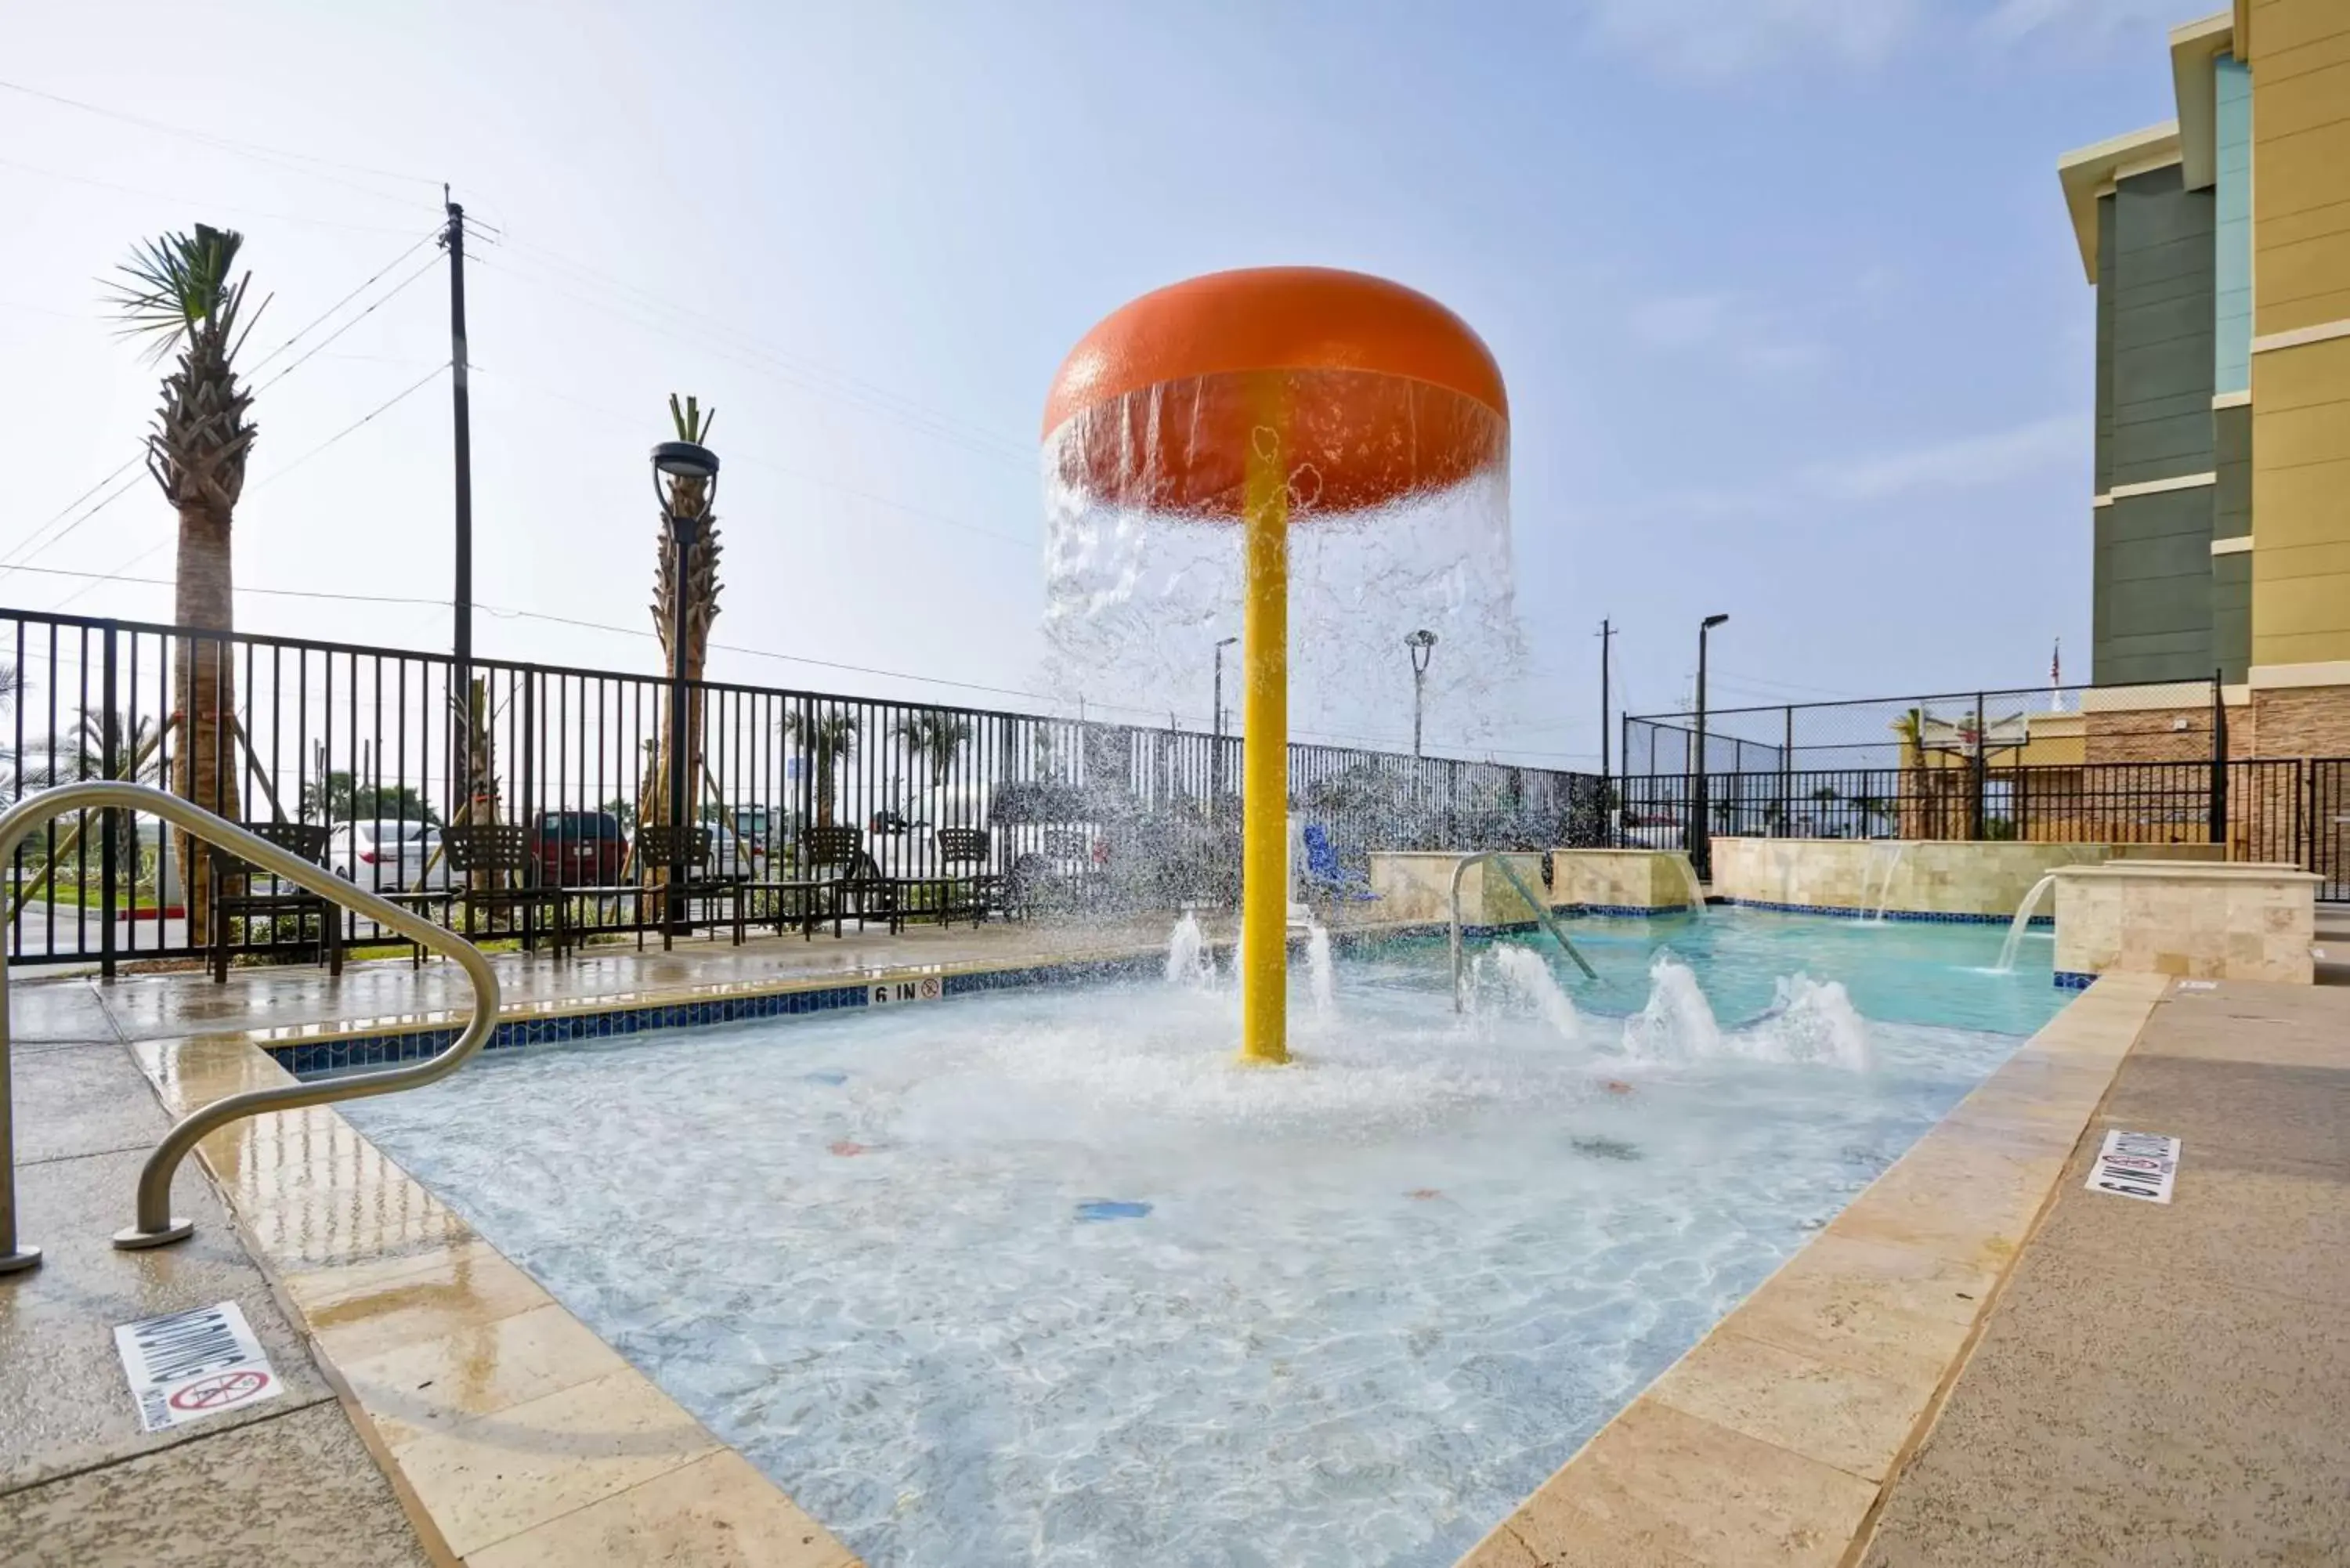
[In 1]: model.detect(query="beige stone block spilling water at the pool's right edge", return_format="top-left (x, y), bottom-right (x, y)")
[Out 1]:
top-left (2056, 861), bottom-right (2317, 985)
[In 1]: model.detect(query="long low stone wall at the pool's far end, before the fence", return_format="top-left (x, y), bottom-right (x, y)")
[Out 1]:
top-left (1711, 840), bottom-right (2115, 917)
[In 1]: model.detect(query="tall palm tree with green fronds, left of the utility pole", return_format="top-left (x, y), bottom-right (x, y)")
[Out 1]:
top-left (110, 223), bottom-right (268, 931)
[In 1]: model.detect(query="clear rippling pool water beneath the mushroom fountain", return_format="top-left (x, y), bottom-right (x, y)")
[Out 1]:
top-left (348, 912), bottom-right (2063, 1568)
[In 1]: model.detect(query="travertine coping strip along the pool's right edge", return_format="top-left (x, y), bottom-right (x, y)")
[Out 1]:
top-left (1462, 974), bottom-right (2171, 1568)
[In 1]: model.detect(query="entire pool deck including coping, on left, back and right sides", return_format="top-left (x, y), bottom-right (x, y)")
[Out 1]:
top-left (0, 922), bottom-right (2350, 1568)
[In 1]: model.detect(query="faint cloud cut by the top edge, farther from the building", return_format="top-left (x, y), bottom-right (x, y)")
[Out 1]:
top-left (1586, 0), bottom-right (1927, 80)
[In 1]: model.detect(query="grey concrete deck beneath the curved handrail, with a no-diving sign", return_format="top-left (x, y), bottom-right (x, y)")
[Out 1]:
top-left (0, 1010), bottom-right (435, 1568)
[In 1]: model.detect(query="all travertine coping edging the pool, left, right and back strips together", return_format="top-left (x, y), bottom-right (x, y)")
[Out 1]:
top-left (132, 929), bottom-right (2169, 1568)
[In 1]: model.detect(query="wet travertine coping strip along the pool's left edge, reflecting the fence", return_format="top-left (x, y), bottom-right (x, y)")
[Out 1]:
top-left (134, 1035), bottom-right (858, 1568)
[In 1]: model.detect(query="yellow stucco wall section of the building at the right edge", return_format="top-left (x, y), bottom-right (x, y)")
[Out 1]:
top-left (2240, 0), bottom-right (2350, 665)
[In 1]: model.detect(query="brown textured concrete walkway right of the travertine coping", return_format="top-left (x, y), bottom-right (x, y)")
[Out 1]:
top-left (1861, 981), bottom-right (2350, 1568)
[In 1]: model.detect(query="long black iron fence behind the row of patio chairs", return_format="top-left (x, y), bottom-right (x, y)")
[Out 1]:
top-left (0, 611), bottom-right (1607, 969)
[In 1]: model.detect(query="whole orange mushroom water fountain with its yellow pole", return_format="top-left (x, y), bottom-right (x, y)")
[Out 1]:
top-left (1043, 268), bottom-right (1509, 1063)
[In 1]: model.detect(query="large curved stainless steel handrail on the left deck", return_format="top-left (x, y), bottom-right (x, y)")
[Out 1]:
top-left (0, 780), bottom-right (498, 1274)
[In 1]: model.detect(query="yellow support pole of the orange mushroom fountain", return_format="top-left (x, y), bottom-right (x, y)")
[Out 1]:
top-left (1241, 399), bottom-right (1290, 1065)
